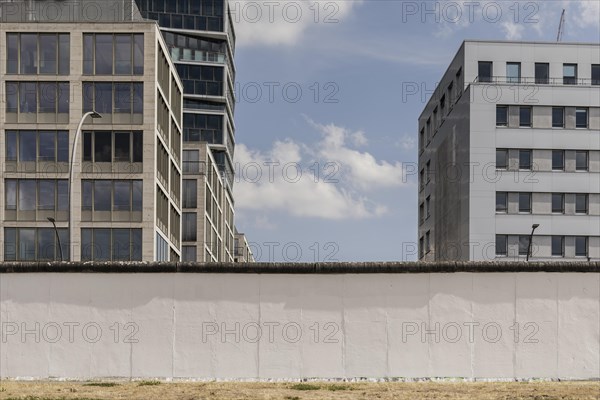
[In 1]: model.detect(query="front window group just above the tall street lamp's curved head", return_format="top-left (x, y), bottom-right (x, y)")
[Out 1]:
top-left (83, 82), bottom-right (144, 114)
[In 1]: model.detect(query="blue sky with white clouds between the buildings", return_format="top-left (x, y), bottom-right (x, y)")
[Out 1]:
top-left (231, 0), bottom-right (600, 262)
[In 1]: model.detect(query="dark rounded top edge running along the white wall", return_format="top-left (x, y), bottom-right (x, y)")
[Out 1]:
top-left (0, 261), bottom-right (600, 275)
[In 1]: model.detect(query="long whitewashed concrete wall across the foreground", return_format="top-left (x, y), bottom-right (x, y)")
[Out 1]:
top-left (0, 264), bottom-right (600, 380)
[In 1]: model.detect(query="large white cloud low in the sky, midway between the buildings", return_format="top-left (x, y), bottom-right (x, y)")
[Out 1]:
top-left (234, 121), bottom-right (403, 219)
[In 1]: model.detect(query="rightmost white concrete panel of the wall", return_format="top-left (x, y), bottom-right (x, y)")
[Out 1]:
top-left (557, 274), bottom-right (600, 379)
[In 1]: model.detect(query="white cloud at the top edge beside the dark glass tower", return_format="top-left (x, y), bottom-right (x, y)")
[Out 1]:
top-left (229, 0), bottom-right (362, 46)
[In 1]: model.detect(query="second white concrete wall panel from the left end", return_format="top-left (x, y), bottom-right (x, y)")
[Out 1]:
top-left (48, 274), bottom-right (133, 377)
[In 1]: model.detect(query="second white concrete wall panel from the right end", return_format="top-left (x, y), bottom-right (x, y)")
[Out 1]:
top-left (515, 273), bottom-right (559, 378)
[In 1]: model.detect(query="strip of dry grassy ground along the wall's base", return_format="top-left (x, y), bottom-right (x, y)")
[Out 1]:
top-left (0, 381), bottom-right (600, 400)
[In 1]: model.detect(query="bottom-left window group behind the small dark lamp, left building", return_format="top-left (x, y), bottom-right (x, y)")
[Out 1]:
top-left (4, 228), bottom-right (70, 261)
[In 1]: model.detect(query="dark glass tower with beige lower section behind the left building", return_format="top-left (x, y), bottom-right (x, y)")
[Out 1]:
top-left (135, 0), bottom-right (235, 262)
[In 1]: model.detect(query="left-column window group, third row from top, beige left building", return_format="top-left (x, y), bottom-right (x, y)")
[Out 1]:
top-left (6, 130), bottom-right (69, 162)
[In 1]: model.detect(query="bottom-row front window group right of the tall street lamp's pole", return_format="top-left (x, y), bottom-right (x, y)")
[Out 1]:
top-left (81, 228), bottom-right (142, 261)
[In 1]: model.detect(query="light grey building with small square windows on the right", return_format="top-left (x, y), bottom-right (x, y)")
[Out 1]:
top-left (418, 41), bottom-right (600, 261)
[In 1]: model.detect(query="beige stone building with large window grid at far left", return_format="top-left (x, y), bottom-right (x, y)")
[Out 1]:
top-left (0, 0), bottom-right (183, 261)
